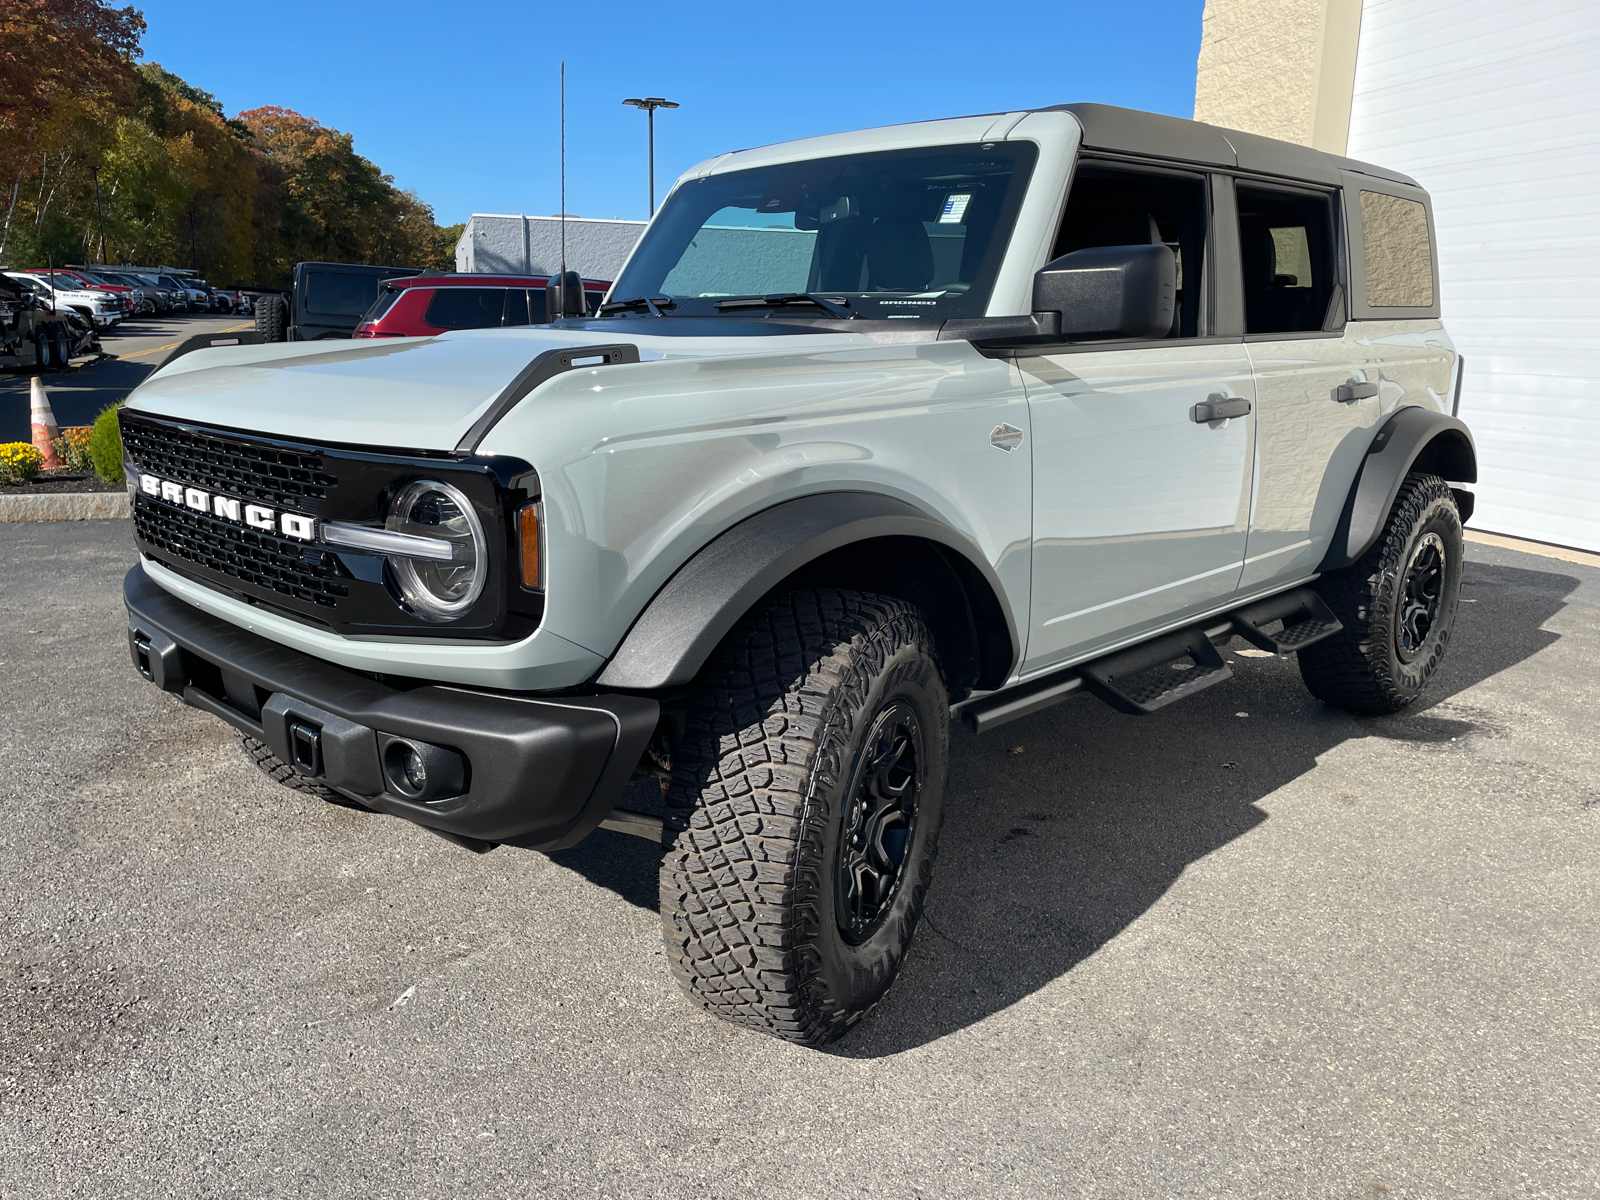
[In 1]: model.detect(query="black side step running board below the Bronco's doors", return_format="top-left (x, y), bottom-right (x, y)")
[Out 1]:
top-left (960, 587), bottom-right (1344, 733)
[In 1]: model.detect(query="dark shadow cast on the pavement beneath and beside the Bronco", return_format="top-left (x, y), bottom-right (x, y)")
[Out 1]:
top-left (552, 562), bottom-right (1578, 1058)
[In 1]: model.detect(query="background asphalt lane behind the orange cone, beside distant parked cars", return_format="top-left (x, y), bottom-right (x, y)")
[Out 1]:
top-left (0, 312), bottom-right (254, 442)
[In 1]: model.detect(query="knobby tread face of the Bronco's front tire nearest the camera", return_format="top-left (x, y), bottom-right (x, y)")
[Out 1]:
top-left (661, 587), bottom-right (933, 1045)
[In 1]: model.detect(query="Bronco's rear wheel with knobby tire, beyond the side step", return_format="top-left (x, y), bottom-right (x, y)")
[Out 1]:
top-left (1299, 474), bottom-right (1462, 715)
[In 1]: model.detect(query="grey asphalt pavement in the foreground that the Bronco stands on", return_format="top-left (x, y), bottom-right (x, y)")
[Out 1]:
top-left (0, 522), bottom-right (1600, 1200)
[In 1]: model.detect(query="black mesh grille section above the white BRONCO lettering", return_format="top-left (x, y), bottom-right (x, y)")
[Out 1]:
top-left (122, 421), bottom-right (338, 514)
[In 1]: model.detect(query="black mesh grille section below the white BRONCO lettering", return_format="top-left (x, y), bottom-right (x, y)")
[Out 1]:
top-left (136, 499), bottom-right (350, 608)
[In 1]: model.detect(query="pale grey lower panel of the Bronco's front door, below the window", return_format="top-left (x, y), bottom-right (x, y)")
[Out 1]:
top-left (1018, 342), bottom-right (1254, 674)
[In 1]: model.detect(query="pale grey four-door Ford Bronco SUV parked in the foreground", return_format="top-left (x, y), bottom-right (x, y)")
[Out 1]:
top-left (122, 104), bottom-right (1477, 1045)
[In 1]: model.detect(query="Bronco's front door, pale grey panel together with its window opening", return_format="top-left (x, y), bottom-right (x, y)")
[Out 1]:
top-left (1018, 162), bottom-right (1254, 672)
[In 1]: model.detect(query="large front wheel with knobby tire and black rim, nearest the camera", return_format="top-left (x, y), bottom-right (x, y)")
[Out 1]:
top-left (661, 587), bottom-right (950, 1046)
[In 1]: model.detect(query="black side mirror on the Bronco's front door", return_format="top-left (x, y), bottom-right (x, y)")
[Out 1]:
top-left (1034, 246), bottom-right (1178, 341)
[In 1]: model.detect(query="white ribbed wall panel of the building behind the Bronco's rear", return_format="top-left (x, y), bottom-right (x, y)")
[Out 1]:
top-left (1349, 0), bottom-right (1600, 550)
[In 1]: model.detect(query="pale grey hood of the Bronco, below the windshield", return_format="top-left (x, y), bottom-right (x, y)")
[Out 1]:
top-left (128, 318), bottom-right (874, 451)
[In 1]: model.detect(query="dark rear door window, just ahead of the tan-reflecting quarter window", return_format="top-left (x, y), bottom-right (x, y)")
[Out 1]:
top-left (1238, 184), bottom-right (1344, 333)
